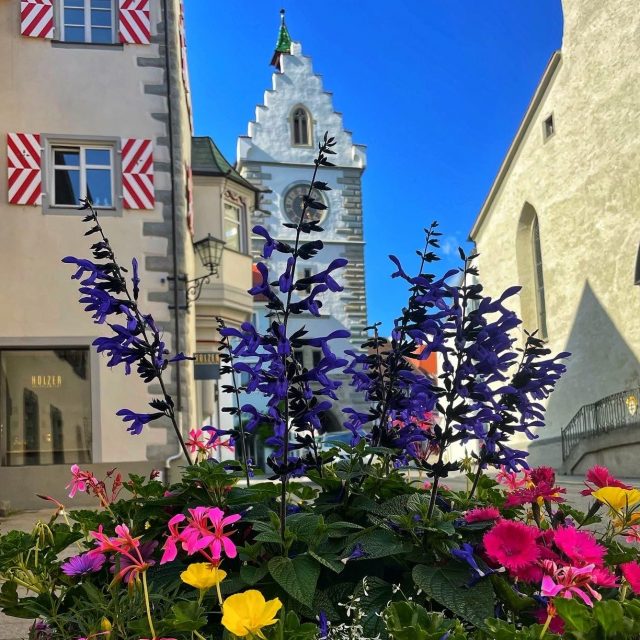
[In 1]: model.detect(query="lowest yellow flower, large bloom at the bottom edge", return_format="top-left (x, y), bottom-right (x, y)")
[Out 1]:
top-left (222, 589), bottom-right (282, 638)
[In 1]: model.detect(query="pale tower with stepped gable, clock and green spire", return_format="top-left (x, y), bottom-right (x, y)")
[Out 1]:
top-left (237, 10), bottom-right (367, 424)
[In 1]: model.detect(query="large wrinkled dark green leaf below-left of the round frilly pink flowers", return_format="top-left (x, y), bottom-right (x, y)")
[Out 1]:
top-left (412, 562), bottom-right (495, 629)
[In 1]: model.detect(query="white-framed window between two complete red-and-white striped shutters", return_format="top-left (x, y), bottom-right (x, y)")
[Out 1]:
top-left (50, 144), bottom-right (115, 209)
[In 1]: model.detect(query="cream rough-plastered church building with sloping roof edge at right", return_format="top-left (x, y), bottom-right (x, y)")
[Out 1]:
top-left (470, 0), bottom-right (640, 475)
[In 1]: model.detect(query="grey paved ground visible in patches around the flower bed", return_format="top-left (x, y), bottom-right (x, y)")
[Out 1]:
top-left (0, 476), bottom-right (638, 640)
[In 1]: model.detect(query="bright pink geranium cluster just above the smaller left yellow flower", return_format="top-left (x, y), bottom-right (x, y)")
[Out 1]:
top-left (160, 507), bottom-right (240, 565)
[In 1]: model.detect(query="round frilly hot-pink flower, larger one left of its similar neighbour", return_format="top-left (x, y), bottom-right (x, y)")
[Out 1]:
top-left (483, 520), bottom-right (540, 571)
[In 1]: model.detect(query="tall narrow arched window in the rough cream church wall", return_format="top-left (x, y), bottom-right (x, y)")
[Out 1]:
top-left (516, 202), bottom-right (548, 340)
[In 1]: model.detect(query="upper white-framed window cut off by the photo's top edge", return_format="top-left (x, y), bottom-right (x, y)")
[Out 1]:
top-left (60, 0), bottom-right (116, 44)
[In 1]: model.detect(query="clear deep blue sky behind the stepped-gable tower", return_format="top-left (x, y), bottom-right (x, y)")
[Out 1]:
top-left (185, 0), bottom-right (562, 330)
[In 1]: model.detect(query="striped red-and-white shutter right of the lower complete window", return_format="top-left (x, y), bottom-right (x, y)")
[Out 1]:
top-left (122, 138), bottom-right (156, 209)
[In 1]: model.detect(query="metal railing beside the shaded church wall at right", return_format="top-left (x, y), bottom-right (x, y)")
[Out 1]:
top-left (561, 387), bottom-right (640, 462)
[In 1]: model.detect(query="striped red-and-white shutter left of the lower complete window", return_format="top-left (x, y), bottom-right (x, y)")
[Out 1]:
top-left (7, 133), bottom-right (42, 206)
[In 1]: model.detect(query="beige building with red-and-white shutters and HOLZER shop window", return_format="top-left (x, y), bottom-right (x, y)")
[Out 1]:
top-left (0, 0), bottom-right (254, 508)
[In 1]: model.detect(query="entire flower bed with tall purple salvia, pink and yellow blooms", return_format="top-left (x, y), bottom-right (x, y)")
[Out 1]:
top-left (5, 131), bottom-right (640, 640)
